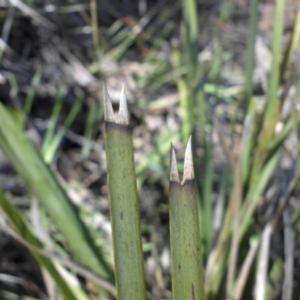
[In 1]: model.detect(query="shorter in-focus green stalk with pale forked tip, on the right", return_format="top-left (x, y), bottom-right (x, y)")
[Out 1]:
top-left (170, 139), bottom-right (205, 300)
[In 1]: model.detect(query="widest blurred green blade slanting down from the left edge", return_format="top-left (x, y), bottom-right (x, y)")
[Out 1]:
top-left (0, 104), bottom-right (113, 286)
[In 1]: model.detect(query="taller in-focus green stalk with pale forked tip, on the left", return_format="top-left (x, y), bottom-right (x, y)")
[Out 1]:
top-left (104, 87), bottom-right (146, 300)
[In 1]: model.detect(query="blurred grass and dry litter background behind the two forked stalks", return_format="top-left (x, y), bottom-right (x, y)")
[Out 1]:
top-left (0, 0), bottom-right (300, 300)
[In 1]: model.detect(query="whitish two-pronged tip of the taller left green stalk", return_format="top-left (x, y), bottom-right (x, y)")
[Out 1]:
top-left (103, 83), bottom-right (129, 125)
